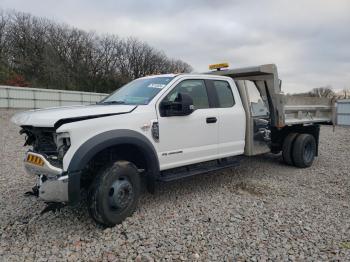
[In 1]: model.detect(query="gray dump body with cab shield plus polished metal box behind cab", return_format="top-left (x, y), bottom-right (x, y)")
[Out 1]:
top-left (209, 64), bottom-right (335, 155)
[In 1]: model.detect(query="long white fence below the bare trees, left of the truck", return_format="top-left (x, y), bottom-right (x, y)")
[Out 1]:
top-left (0, 85), bottom-right (107, 109)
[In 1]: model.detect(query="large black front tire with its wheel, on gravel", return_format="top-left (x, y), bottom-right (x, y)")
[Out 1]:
top-left (88, 161), bottom-right (141, 227)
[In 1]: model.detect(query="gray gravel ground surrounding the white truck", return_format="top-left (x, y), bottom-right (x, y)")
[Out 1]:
top-left (0, 110), bottom-right (350, 261)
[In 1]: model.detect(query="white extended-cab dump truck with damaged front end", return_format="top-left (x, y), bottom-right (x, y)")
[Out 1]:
top-left (12, 64), bottom-right (333, 226)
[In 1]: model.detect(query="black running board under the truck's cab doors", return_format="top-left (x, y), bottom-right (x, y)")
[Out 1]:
top-left (158, 157), bottom-right (239, 182)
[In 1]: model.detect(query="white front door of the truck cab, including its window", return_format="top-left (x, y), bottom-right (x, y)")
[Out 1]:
top-left (157, 79), bottom-right (219, 170)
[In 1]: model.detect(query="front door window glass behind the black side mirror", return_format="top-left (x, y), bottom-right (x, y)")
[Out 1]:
top-left (164, 79), bottom-right (209, 109)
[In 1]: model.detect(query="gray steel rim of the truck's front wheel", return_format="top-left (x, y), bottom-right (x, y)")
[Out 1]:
top-left (108, 177), bottom-right (134, 211)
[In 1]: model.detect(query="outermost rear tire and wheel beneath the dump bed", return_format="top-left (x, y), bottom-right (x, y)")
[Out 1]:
top-left (293, 134), bottom-right (316, 168)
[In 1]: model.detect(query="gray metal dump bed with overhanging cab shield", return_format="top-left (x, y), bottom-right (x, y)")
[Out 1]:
top-left (210, 64), bottom-right (335, 127)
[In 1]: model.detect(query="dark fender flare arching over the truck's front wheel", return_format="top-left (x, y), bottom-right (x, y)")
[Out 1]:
top-left (67, 129), bottom-right (159, 204)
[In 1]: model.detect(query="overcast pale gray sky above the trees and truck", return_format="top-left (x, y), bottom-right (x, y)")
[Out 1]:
top-left (0, 0), bottom-right (350, 93)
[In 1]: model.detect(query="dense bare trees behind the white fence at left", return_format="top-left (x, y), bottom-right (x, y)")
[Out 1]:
top-left (0, 11), bottom-right (192, 92)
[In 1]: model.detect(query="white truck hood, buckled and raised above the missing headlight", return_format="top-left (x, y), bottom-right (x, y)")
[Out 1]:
top-left (11, 105), bottom-right (136, 128)
